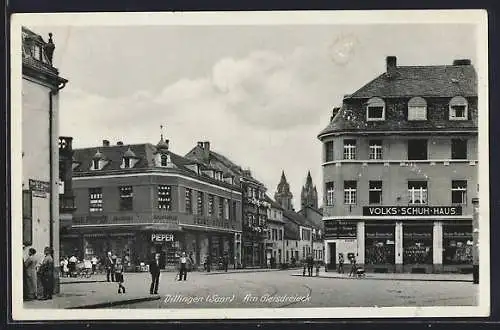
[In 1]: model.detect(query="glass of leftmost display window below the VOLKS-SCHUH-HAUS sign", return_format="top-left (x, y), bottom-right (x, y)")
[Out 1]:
top-left (365, 225), bottom-right (395, 265)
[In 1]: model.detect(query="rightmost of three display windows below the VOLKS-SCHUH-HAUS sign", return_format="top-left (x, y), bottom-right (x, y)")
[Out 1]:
top-left (443, 225), bottom-right (473, 265)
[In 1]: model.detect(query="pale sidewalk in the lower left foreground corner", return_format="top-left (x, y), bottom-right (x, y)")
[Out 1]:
top-left (24, 275), bottom-right (160, 309)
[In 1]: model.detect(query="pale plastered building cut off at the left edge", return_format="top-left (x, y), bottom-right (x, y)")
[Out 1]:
top-left (19, 27), bottom-right (67, 292)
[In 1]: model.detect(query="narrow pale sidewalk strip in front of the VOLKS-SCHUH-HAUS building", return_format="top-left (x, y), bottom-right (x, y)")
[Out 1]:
top-left (292, 271), bottom-right (472, 282)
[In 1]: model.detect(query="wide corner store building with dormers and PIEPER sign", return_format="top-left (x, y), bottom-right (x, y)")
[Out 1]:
top-left (65, 135), bottom-right (242, 269)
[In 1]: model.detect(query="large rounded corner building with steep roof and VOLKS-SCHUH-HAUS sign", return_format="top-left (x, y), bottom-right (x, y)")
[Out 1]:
top-left (318, 56), bottom-right (478, 273)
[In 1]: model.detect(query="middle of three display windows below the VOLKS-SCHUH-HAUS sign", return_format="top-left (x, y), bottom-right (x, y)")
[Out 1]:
top-left (403, 225), bottom-right (432, 265)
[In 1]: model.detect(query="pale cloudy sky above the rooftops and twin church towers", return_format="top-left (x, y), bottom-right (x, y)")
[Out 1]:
top-left (28, 24), bottom-right (477, 209)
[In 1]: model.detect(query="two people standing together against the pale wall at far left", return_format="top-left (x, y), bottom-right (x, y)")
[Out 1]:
top-left (23, 247), bottom-right (54, 301)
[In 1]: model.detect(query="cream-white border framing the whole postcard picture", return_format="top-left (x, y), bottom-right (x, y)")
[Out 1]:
top-left (8, 10), bottom-right (490, 320)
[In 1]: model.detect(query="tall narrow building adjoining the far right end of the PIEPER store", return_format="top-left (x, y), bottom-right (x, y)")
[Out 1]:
top-left (186, 141), bottom-right (270, 267)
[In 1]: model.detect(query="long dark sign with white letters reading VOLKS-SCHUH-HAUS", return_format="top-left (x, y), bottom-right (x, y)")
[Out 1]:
top-left (363, 206), bottom-right (462, 217)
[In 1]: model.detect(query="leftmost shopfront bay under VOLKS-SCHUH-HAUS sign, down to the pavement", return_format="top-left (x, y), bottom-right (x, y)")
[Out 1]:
top-left (365, 221), bottom-right (396, 272)
